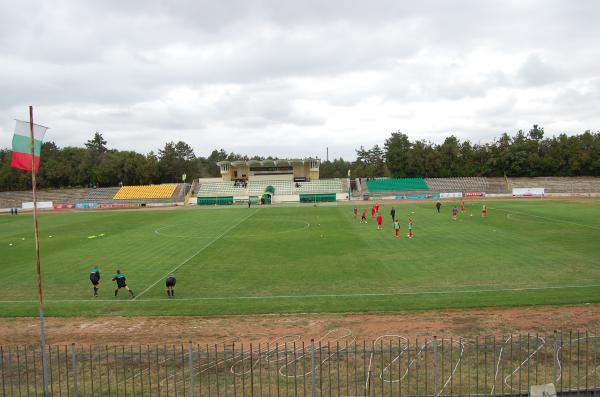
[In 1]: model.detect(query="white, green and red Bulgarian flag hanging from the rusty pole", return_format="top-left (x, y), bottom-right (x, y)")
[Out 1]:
top-left (10, 120), bottom-right (48, 172)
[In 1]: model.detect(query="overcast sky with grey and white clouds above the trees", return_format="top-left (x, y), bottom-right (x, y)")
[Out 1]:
top-left (0, 0), bottom-right (600, 159)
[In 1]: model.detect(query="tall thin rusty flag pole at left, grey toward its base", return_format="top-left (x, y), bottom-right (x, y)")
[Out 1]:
top-left (29, 106), bottom-right (49, 396)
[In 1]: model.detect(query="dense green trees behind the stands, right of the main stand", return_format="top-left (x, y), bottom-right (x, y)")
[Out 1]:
top-left (321, 125), bottom-right (600, 178)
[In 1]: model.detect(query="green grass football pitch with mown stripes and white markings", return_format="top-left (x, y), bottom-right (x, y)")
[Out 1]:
top-left (0, 200), bottom-right (600, 317)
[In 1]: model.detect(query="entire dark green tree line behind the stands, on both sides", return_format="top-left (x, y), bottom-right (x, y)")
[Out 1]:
top-left (0, 125), bottom-right (600, 190)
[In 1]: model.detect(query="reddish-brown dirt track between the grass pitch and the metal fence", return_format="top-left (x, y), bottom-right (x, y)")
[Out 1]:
top-left (0, 304), bottom-right (600, 344)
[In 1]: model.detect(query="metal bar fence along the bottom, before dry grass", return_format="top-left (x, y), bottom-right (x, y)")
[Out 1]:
top-left (0, 333), bottom-right (600, 397)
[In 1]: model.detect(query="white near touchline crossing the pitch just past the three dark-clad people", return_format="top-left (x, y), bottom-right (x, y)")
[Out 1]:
top-left (0, 279), bottom-right (600, 303)
